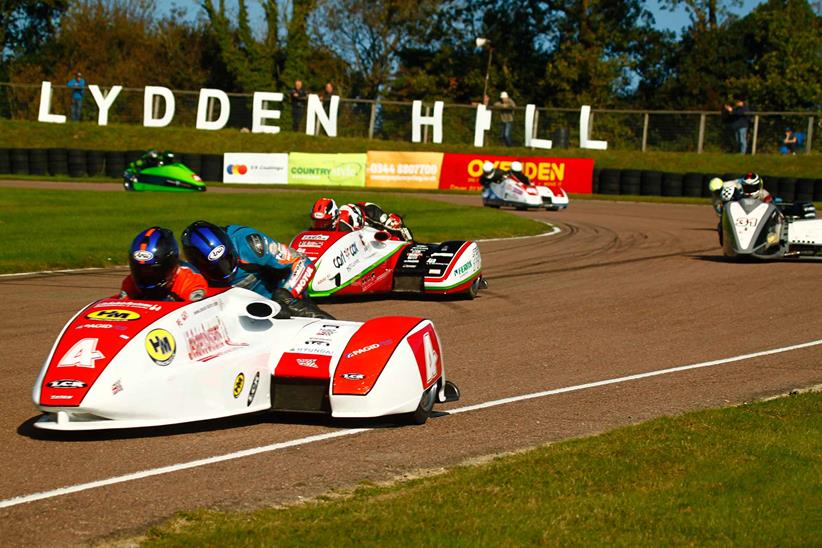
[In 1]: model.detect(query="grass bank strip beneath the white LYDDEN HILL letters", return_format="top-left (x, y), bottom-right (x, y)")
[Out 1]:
top-left (0, 120), bottom-right (822, 178)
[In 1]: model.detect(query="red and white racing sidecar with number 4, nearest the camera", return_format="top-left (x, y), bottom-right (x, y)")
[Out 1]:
top-left (32, 288), bottom-right (459, 431)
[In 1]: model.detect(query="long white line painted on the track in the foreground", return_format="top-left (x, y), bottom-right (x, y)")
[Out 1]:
top-left (0, 339), bottom-right (822, 508)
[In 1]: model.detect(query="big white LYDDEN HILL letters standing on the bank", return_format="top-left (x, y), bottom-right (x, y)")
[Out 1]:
top-left (37, 81), bottom-right (608, 150)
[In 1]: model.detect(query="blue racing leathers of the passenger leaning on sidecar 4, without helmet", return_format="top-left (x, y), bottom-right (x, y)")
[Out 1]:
top-left (225, 225), bottom-right (333, 319)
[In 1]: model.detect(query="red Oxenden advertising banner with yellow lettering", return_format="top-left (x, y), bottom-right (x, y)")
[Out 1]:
top-left (439, 153), bottom-right (594, 194)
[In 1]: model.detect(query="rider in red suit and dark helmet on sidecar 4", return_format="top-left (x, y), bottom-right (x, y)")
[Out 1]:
top-left (120, 226), bottom-right (208, 301)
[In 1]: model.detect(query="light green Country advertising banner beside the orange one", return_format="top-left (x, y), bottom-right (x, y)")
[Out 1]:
top-left (288, 152), bottom-right (366, 186)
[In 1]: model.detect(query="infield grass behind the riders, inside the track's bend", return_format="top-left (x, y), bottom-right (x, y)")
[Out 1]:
top-left (0, 188), bottom-right (546, 273)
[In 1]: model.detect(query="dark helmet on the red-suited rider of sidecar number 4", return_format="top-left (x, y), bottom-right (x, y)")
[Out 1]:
top-left (128, 226), bottom-right (180, 291)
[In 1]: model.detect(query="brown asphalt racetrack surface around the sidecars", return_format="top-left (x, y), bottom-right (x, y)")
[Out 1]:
top-left (0, 186), bottom-right (822, 546)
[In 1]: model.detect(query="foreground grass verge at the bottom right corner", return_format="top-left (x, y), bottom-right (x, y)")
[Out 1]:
top-left (142, 393), bottom-right (822, 547)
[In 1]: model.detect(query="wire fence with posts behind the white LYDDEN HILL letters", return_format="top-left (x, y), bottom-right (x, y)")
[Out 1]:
top-left (0, 82), bottom-right (822, 154)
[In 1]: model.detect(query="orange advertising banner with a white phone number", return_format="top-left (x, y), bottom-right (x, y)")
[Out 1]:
top-left (365, 150), bottom-right (443, 189)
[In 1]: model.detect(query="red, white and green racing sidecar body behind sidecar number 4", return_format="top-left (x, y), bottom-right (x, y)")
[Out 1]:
top-left (291, 226), bottom-right (485, 299)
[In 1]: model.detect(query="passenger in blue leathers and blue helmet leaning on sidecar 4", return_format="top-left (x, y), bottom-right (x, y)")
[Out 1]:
top-left (182, 221), bottom-right (333, 319)
